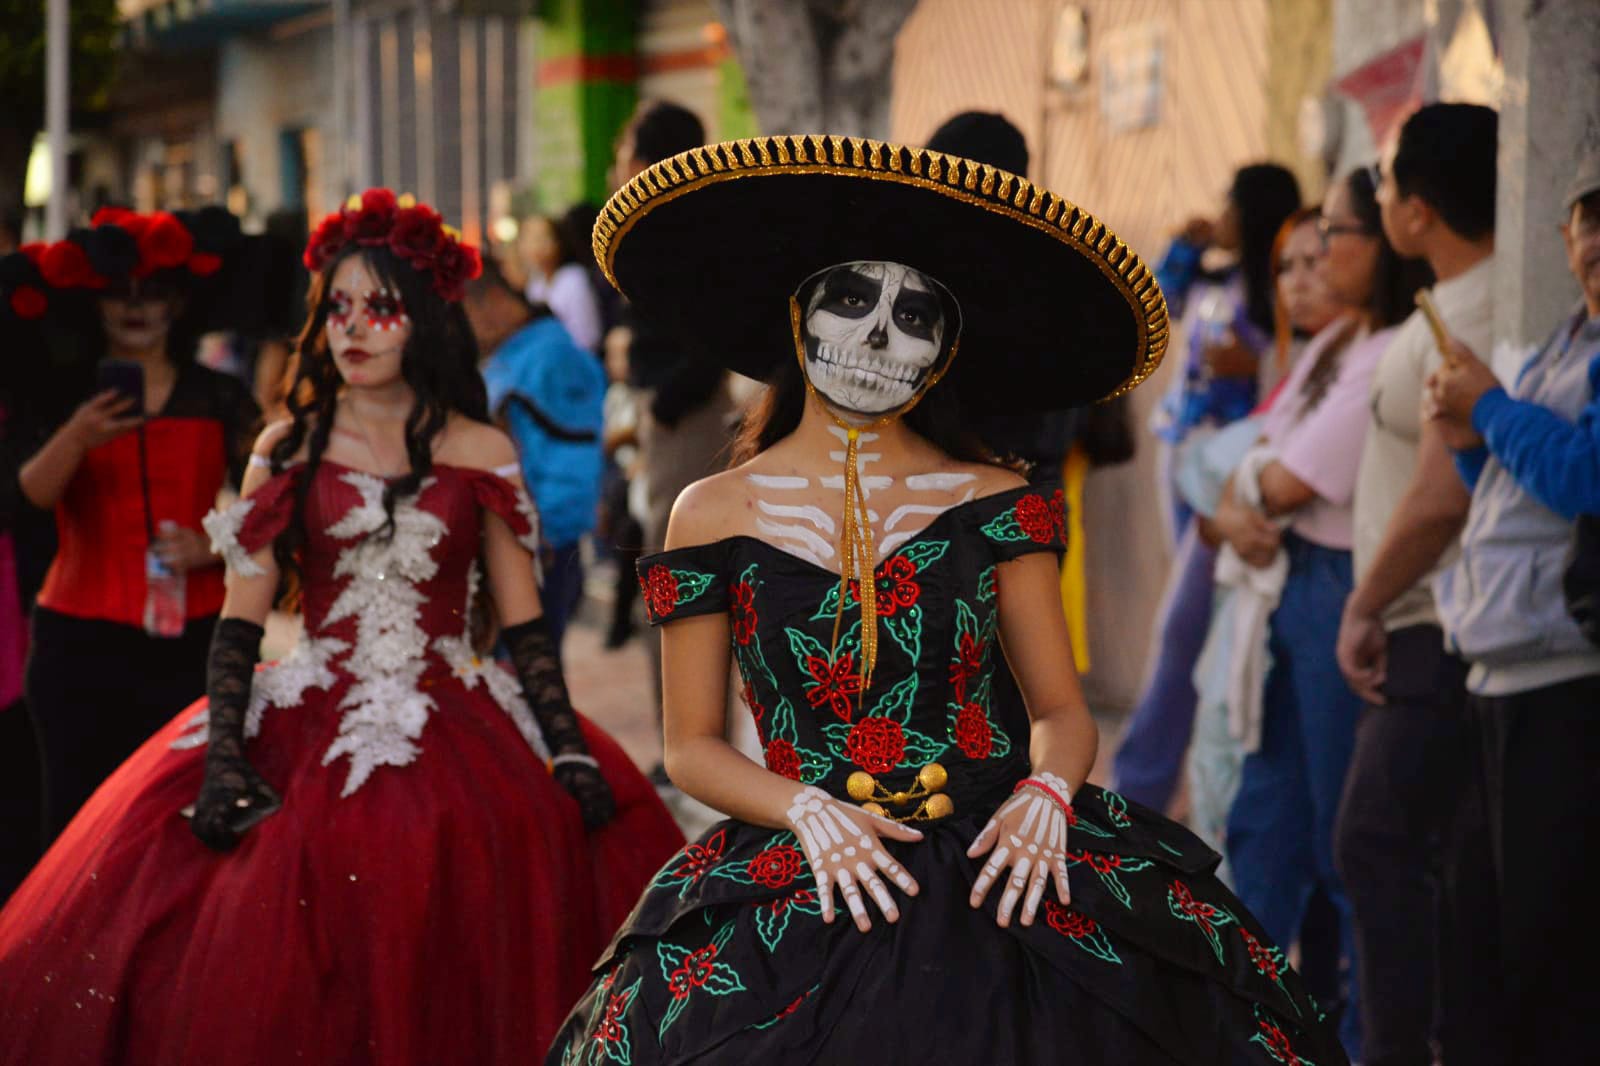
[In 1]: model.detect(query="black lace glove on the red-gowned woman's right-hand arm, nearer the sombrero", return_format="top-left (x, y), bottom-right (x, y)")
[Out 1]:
top-left (501, 616), bottom-right (616, 829)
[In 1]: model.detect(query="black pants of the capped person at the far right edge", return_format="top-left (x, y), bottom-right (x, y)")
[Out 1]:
top-left (1458, 675), bottom-right (1600, 1066)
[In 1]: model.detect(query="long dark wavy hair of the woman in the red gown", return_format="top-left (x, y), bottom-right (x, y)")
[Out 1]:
top-left (272, 245), bottom-right (490, 573)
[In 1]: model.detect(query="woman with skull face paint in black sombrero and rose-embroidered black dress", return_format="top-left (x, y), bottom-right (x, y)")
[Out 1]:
top-left (549, 138), bottom-right (1344, 1066)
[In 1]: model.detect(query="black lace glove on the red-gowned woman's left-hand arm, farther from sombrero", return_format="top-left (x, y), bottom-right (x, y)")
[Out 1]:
top-left (189, 618), bottom-right (283, 852)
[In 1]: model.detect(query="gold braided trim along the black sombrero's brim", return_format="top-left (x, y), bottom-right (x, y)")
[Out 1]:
top-left (594, 134), bottom-right (1170, 395)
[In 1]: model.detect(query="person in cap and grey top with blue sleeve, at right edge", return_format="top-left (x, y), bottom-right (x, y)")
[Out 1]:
top-left (1424, 149), bottom-right (1600, 1063)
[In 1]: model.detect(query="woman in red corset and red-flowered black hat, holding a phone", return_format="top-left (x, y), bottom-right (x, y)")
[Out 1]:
top-left (11, 208), bottom-right (259, 845)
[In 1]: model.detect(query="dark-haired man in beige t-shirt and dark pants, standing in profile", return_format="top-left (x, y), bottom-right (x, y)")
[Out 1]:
top-left (1334, 104), bottom-right (1498, 1066)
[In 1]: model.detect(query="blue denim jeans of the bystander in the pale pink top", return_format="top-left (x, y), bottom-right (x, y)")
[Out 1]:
top-left (1227, 533), bottom-right (1362, 1060)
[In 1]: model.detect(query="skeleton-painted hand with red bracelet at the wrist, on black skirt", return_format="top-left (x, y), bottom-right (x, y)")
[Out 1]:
top-left (966, 773), bottom-right (1072, 925)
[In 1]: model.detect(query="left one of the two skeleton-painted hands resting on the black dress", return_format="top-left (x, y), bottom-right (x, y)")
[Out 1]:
top-left (784, 786), bottom-right (922, 933)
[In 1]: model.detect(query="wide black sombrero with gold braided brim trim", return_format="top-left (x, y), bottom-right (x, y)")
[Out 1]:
top-left (594, 136), bottom-right (1168, 411)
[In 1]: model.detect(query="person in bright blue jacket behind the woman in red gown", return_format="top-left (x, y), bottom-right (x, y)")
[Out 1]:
top-left (462, 259), bottom-right (606, 647)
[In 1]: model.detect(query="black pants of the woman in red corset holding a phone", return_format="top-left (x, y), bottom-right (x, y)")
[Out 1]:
top-left (27, 607), bottom-right (216, 847)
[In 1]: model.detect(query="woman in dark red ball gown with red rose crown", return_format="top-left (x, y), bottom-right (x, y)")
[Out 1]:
top-left (0, 190), bottom-right (682, 1066)
